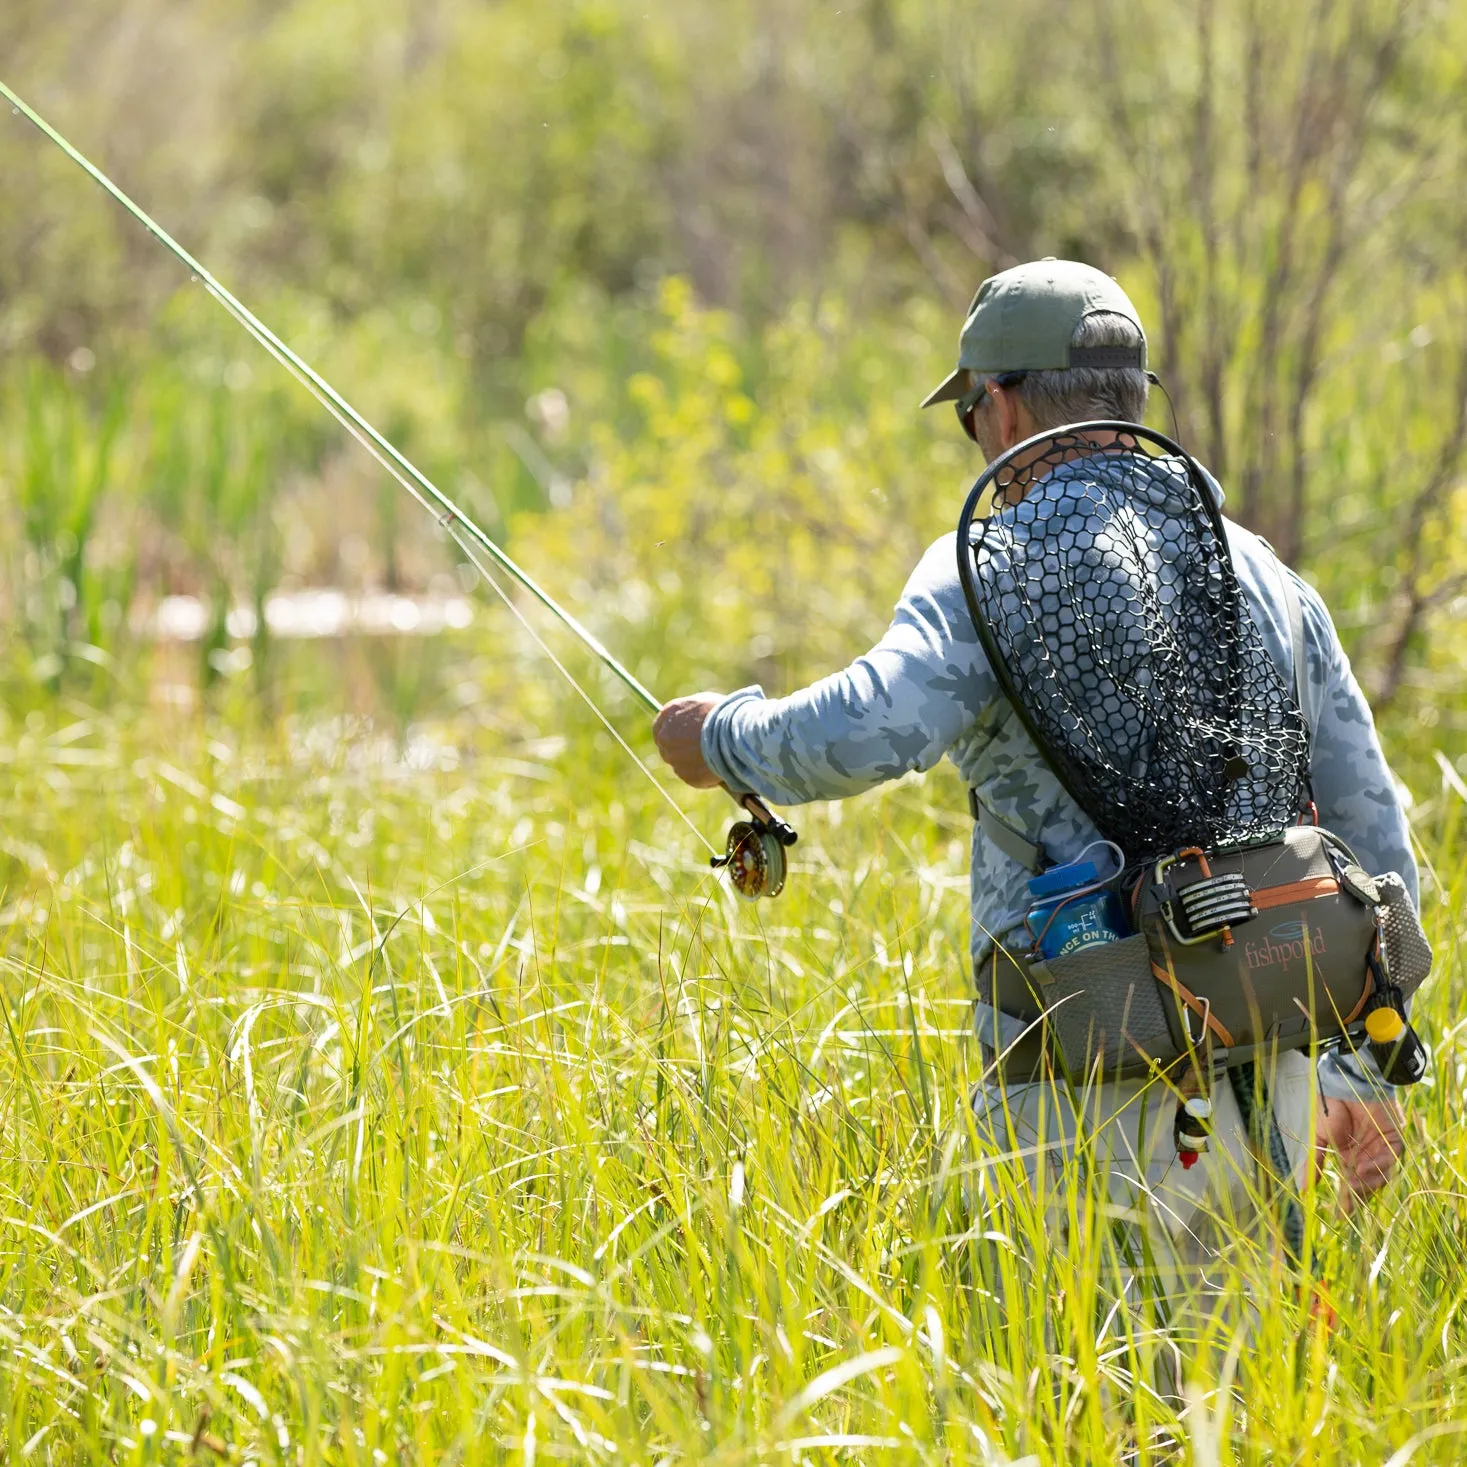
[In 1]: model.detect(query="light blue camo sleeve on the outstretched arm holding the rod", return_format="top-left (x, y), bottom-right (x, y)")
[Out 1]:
top-left (703, 535), bottom-right (999, 805)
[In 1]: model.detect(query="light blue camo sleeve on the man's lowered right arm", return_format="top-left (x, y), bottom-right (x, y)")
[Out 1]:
top-left (1288, 572), bottom-right (1420, 1100)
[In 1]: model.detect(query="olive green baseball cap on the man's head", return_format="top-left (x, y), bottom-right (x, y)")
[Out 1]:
top-left (923, 255), bottom-right (1146, 408)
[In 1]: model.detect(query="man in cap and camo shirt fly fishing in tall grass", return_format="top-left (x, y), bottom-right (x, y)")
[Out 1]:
top-left (654, 260), bottom-right (1429, 1361)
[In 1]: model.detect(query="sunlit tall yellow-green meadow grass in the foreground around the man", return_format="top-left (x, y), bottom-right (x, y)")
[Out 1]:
top-left (0, 671), bottom-right (1467, 1467)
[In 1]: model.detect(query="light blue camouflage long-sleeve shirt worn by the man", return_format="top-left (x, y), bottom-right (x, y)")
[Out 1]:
top-left (703, 469), bottom-right (1417, 1097)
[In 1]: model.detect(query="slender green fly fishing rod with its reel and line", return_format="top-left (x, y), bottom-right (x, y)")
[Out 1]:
top-left (0, 81), bottom-right (797, 901)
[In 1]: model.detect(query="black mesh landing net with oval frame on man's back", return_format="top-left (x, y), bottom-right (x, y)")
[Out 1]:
top-left (958, 424), bottom-right (1309, 861)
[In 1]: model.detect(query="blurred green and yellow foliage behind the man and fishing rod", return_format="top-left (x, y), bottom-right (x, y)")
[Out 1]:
top-left (0, 0), bottom-right (1467, 745)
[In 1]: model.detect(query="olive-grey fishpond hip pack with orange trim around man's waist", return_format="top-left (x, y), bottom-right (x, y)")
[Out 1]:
top-left (978, 826), bottom-right (1432, 1078)
